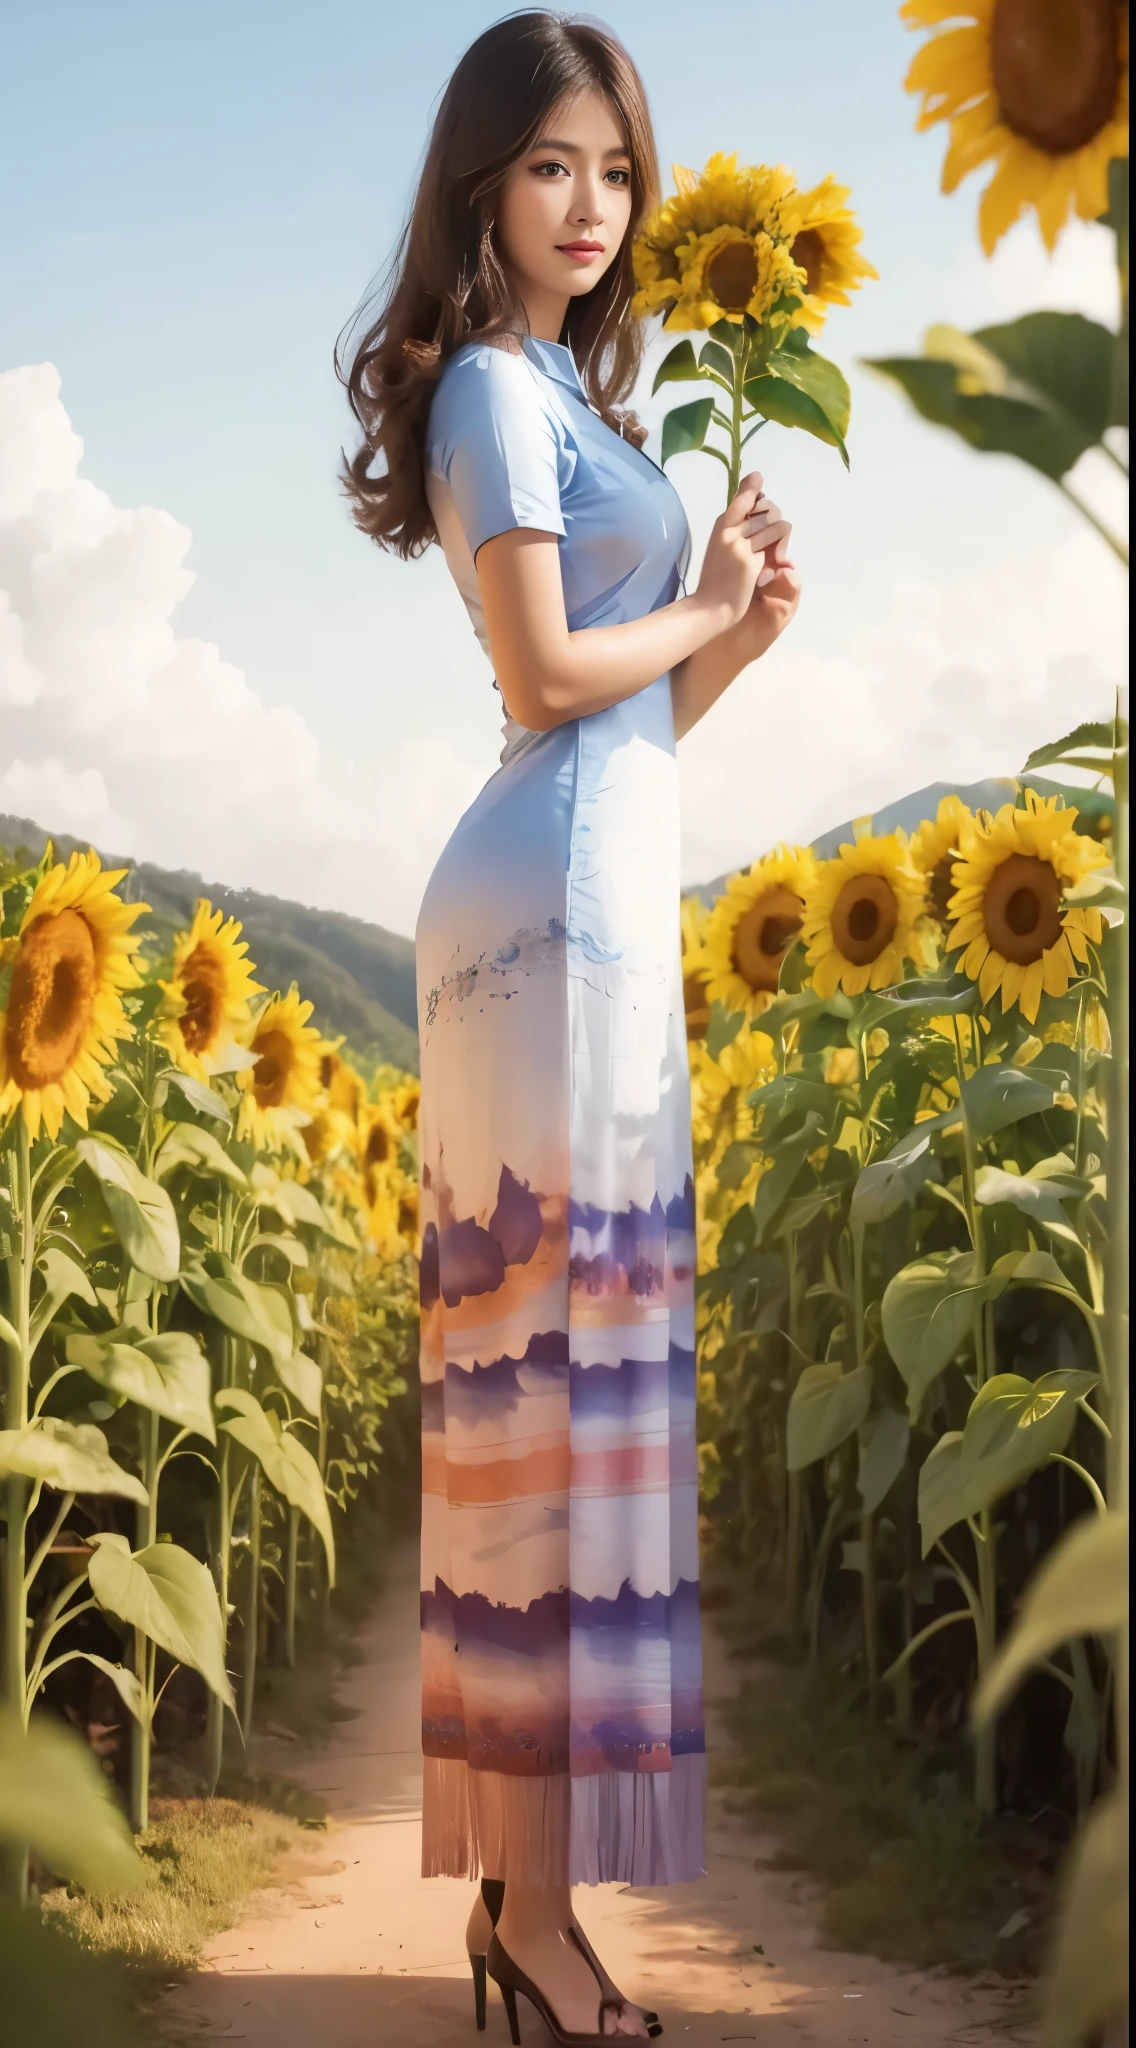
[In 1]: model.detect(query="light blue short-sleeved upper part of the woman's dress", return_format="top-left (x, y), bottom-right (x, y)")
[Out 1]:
top-left (426, 336), bottom-right (690, 688)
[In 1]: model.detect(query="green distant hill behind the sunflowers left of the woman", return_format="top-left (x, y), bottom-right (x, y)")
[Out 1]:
top-left (0, 813), bottom-right (418, 1071)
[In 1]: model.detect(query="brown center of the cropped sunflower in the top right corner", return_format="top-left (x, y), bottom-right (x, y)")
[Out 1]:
top-left (991, 0), bottom-right (1120, 156)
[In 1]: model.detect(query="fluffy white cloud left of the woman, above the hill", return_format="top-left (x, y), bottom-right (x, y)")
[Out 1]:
top-left (0, 365), bottom-right (493, 930)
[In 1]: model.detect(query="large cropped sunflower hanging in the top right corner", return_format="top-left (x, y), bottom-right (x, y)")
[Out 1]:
top-left (899, 0), bottom-right (1128, 256)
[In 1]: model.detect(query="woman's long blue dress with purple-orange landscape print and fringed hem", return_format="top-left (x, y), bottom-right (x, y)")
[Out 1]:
top-left (418, 338), bottom-right (706, 1884)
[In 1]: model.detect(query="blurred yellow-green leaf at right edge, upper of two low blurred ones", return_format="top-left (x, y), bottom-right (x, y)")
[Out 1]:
top-left (974, 1513), bottom-right (1128, 1724)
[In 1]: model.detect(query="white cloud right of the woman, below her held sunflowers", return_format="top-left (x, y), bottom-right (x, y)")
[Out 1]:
top-left (680, 535), bottom-right (1126, 881)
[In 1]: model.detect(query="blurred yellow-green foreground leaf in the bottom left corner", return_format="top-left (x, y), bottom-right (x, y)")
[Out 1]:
top-left (0, 1714), bottom-right (149, 1892)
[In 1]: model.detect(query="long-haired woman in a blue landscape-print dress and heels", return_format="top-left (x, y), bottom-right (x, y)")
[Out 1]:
top-left (344, 12), bottom-right (798, 2042)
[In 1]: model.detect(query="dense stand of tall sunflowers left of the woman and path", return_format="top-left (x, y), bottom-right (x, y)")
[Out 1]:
top-left (0, 848), bottom-right (418, 1896)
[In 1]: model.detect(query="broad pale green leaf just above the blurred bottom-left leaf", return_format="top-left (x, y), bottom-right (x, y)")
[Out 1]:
top-left (88, 1530), bottom-right (235, 1710)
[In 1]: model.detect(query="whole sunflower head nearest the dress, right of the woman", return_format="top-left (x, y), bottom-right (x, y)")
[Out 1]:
top-left (702, 846), bottom-right (815, 1018)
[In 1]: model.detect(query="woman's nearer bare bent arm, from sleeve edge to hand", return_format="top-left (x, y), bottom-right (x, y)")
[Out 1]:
top-left (477, 475), bottom-right (788, 733)
